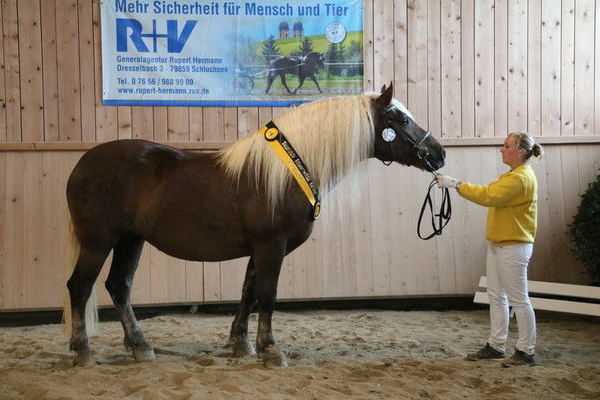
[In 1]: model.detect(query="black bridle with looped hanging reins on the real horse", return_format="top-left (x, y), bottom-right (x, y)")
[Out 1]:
top-left (380, 105), bottom-right (452, 240)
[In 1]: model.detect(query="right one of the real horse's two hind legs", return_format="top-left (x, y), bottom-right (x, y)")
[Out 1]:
top-left (106, 234), bottom-right (155, 362)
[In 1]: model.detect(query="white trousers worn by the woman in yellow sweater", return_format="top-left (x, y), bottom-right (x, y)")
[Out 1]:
top-left (486, 242), bottom-right (536, 355)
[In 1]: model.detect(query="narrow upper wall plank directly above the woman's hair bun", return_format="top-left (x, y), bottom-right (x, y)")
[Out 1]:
top-left (527, 1), bottom-right (542, 136)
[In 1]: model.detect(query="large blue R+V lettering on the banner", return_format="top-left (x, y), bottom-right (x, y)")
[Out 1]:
top-left (117, 18), bottom-right (198, 53)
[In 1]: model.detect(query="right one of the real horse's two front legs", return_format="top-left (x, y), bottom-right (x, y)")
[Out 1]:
top-left (253, 241), bottom-right (287, 367)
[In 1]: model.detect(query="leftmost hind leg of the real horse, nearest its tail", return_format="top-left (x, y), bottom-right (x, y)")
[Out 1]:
top-left (67, 245), bottom-right (109, 366)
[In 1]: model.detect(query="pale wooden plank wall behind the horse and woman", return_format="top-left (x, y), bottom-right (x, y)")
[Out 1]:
top-left (0, 0), bottom-right (600, 310)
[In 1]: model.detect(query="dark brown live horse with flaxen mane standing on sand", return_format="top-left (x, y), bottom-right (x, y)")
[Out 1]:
top-left (65, 84), bottom-right (445, 366)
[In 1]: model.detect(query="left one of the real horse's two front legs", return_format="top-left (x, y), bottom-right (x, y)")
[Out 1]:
top-left (228, 257), bottom-right (256, 357)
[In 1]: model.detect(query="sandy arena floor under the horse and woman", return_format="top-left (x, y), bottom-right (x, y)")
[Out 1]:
top-left (0, 310), bottom-right (600, 400)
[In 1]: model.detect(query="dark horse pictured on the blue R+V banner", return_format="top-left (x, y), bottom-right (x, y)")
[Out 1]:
top-left (265, 51), bottom-right (325, 94)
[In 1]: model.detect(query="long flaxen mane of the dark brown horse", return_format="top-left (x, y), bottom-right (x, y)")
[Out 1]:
top-left (217, 93), bottom-right (412, 210)
